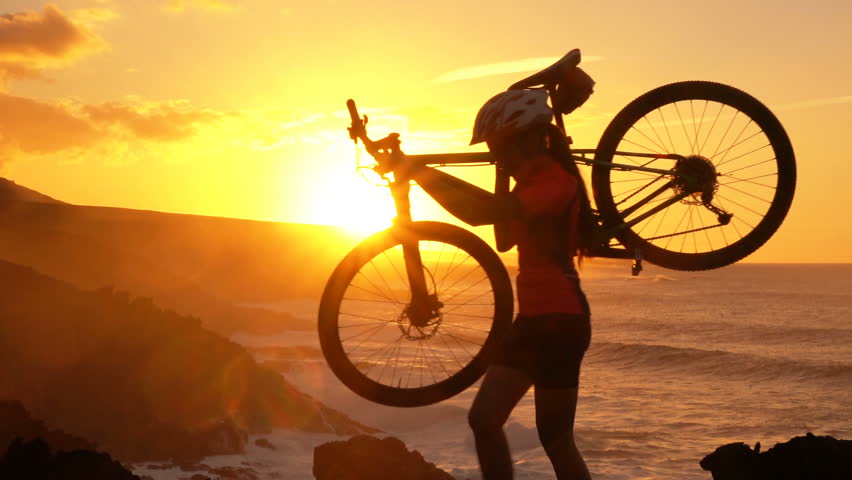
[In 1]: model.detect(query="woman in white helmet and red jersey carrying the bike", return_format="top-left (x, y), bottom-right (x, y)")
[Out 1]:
top-left (394, 89), bottom-right (594, 480)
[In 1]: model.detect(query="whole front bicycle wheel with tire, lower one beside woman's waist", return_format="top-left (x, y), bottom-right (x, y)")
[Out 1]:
top-left (319, 222), bottom-right (514, 407)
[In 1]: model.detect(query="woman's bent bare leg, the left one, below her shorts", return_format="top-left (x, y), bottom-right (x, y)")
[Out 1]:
top-left (468, 365), bottom-right (532, 480)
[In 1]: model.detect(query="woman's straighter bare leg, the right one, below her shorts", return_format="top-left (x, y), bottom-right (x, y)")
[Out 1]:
top-left (535, 386), bottom-right (591, 480)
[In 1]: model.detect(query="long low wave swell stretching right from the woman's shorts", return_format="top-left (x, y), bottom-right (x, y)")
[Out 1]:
top-left (586, 342), bottom-right (852, 381)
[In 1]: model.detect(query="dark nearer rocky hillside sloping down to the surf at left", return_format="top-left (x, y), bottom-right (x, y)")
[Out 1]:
top-left (0, 261), bottom-right (375, 461)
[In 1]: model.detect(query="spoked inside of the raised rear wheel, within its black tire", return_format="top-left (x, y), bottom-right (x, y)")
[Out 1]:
top-left (609, 99), bottom-right (780, 254)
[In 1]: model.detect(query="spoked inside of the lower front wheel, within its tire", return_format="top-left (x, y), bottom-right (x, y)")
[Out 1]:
top-left (337, 240), bottom-right (497, 391)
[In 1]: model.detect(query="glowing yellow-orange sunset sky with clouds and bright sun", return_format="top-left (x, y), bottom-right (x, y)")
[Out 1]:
top-left (0, 0), bottom-right (852, 262)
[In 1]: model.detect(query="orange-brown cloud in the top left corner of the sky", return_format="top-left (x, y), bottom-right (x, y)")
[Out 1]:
top-left (0, 5), bottom-right (109, 85)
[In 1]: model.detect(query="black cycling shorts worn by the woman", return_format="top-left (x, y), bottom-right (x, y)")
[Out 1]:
top-left (494, 313), bottom-right (592, 388)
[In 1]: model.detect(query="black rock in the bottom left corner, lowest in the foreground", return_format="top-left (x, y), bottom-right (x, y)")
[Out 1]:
top-left (0, 438), bottom-right (140, 480)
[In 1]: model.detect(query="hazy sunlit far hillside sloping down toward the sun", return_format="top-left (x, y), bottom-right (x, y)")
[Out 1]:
top-left (0, 182), bottom-right (359, 335)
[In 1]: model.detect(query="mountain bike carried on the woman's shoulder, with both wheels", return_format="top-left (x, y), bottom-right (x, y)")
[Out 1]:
top-left (318, 50), bottom-right (796, 407)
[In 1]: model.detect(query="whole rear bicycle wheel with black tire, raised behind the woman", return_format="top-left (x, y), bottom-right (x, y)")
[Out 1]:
top-left (592, 81), bottom-right (796, 270)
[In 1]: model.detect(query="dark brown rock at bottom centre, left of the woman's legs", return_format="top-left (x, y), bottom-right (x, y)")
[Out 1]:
top-left (313, 435), bottom-right (454, 480)
